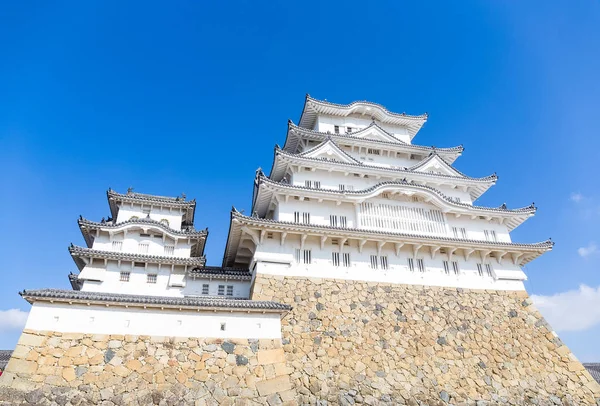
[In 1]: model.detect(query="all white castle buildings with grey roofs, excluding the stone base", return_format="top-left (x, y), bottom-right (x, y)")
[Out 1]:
top-left (21, 96), bottom-right (552, 338)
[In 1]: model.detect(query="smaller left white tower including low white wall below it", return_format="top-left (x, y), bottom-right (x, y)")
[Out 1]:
top-left (21, 189), bottom-right (289, 338)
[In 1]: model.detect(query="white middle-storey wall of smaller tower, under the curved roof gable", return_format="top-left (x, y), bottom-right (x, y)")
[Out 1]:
top-left (92, 232), bottom-right (192, 258)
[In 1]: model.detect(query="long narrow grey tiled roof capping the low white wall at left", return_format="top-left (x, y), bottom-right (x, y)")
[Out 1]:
top-left (19, 289), bottom-right (291, 312)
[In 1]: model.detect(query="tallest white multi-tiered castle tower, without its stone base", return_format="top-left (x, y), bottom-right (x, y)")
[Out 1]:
top-left (223, 95), bottom-right (553, 290)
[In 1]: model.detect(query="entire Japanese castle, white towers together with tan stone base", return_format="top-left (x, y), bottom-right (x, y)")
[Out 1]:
top-left (0, 96), bottom-right (600, 406)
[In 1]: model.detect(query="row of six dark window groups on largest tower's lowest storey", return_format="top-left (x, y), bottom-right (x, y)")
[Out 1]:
top-left (295, 248), bottom-right (492, 277)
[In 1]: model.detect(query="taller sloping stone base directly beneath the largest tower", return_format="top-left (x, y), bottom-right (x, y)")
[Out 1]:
top-left (252, 275), bottom-right (600, 406)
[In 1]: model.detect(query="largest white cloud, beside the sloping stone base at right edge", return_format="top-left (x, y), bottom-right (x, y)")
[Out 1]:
top-left (531, 285), bottom-right (600, 331)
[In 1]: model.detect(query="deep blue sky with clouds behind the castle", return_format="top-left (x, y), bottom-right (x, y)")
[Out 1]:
top-left (0, 0), bottom-right (600, 361)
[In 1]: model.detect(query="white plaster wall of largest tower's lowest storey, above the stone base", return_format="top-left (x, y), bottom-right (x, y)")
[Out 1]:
top-left (254, 235), bottom-right (526, 290)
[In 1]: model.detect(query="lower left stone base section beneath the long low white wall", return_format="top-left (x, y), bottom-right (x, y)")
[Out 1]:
top-left (0, 330), bottom-right (296, 406)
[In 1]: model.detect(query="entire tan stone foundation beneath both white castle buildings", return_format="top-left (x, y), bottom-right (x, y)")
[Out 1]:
top-left (0, 275), bottom-right (600, 406)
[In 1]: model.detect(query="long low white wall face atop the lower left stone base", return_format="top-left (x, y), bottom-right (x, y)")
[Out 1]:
top-left (25, 302), bottom-right (281, 339)
